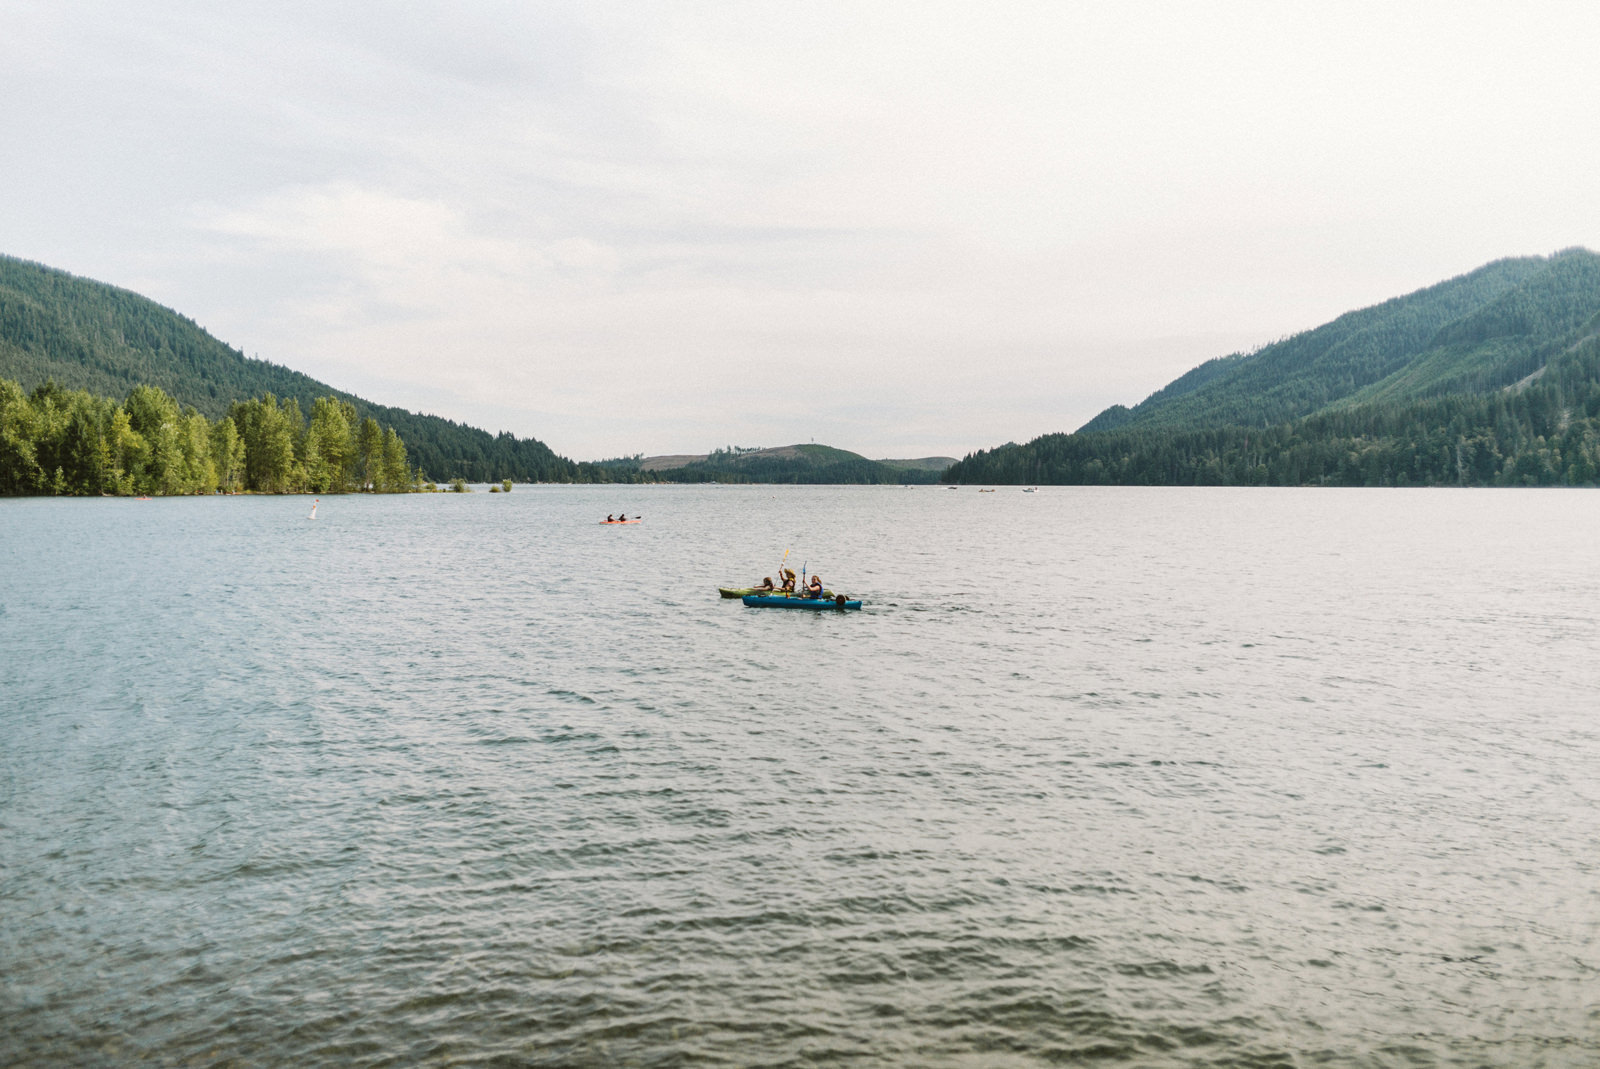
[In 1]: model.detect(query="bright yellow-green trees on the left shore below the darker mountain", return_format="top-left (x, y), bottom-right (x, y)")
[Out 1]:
top-left (0, 379), bottom-right (411, 494)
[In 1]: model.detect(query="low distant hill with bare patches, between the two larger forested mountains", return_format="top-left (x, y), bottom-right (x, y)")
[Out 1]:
top-left (635, 443), bottom-right (949, 483)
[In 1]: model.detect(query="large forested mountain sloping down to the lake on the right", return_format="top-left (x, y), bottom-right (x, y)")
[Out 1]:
top-left (947, 250), bottom-right (1600, 485)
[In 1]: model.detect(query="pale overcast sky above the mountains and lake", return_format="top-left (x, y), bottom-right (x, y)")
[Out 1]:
top-left (0, 0), bottom-right (1600, 459)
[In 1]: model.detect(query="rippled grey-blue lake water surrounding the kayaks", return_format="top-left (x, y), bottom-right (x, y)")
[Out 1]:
top-left (0, 486), bottom-right (1600, 1067)
